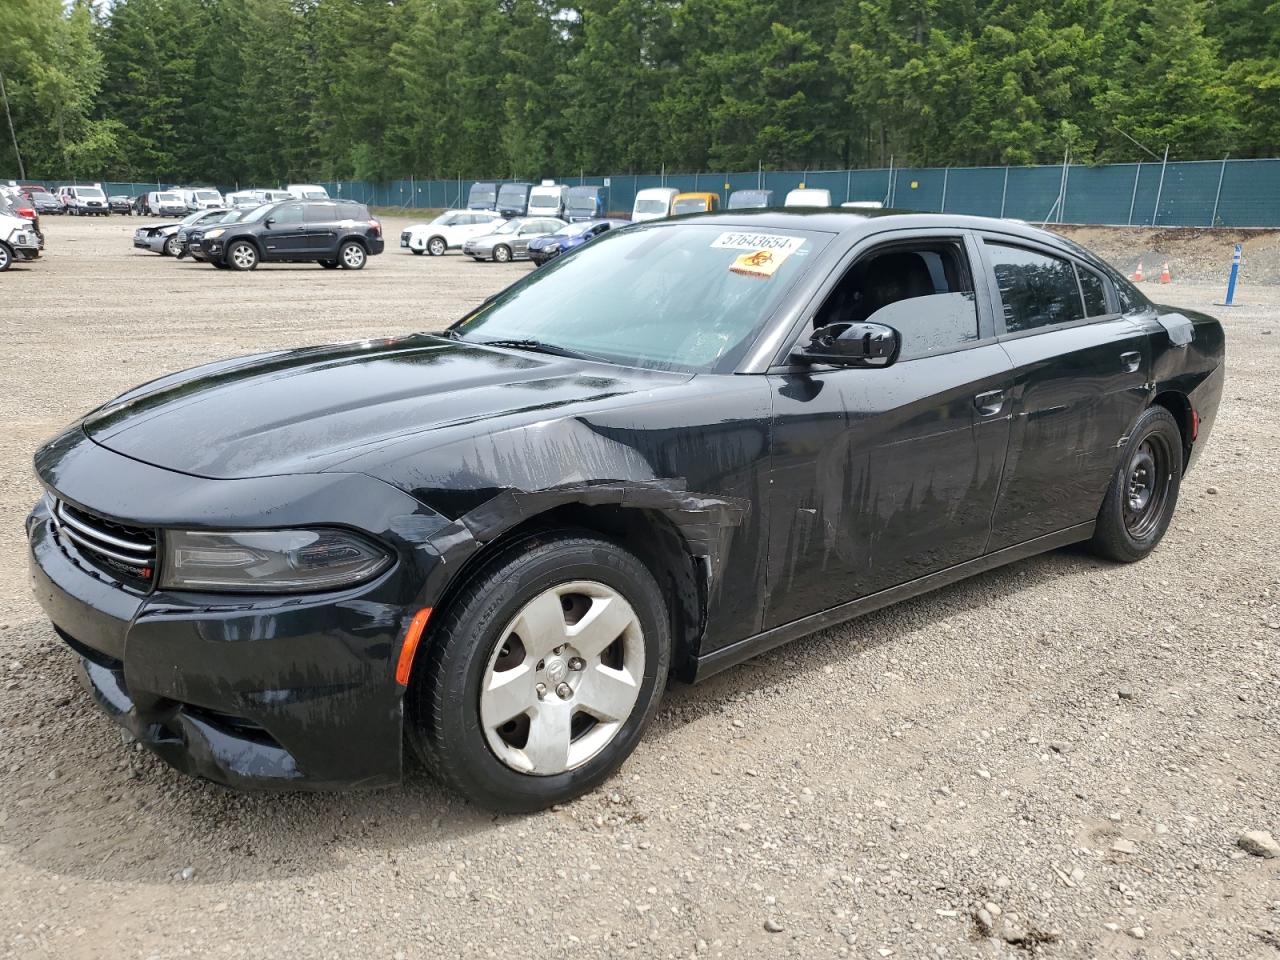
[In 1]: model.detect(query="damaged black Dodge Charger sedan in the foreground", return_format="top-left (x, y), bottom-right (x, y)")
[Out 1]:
top-left (27, 207), bottom-right (1224, 810)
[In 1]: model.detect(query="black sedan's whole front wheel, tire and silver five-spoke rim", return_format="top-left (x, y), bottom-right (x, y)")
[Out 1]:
top-left (406, 531), bottom-right (671, 813)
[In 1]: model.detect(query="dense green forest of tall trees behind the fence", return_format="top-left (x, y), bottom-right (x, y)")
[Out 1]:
top-left (0, 0), bottom-right (1280, 183)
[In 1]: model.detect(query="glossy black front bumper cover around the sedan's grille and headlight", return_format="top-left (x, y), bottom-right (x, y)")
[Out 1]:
top-left (27, 434), bottom-right (455, 790)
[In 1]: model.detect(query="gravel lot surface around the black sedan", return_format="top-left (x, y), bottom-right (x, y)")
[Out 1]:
top-left (0, 216), bottom-right (1280, 960)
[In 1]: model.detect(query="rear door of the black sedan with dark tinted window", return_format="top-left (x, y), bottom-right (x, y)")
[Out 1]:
top-left (982, 234), bottom-right (1151, 550)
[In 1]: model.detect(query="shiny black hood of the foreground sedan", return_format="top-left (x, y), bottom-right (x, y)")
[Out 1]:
top-left (83, 334), bottom-right (689, 479)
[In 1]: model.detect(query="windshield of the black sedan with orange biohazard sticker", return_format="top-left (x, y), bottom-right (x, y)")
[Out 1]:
top-left (453, 223), bottom-right (829, 372)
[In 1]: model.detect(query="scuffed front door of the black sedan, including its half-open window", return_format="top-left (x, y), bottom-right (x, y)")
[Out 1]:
top-left (764, 232), bottom-right (1012, 628)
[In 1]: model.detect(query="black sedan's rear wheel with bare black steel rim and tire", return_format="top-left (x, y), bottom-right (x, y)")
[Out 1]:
top-left (1091, 407), bottom-right (1183, 563)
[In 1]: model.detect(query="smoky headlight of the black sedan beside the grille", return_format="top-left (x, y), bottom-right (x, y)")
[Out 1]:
top-left (160, 529), bottom-right (392, 594)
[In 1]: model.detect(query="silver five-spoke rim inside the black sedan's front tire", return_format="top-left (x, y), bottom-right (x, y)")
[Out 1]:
top-left (480, 580), bottom-right (645, 776)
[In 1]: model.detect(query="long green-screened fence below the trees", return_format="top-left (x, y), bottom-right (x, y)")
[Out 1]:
top-left (17, 159), bottom-right (1280, 227)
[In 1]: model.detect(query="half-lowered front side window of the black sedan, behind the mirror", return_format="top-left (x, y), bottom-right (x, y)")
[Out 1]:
top-left (814, 239), bottom-right (978, 360)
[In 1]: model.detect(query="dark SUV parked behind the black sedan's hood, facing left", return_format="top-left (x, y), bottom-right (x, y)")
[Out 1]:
top-left (188, 200), bottom-right (383, 270)
